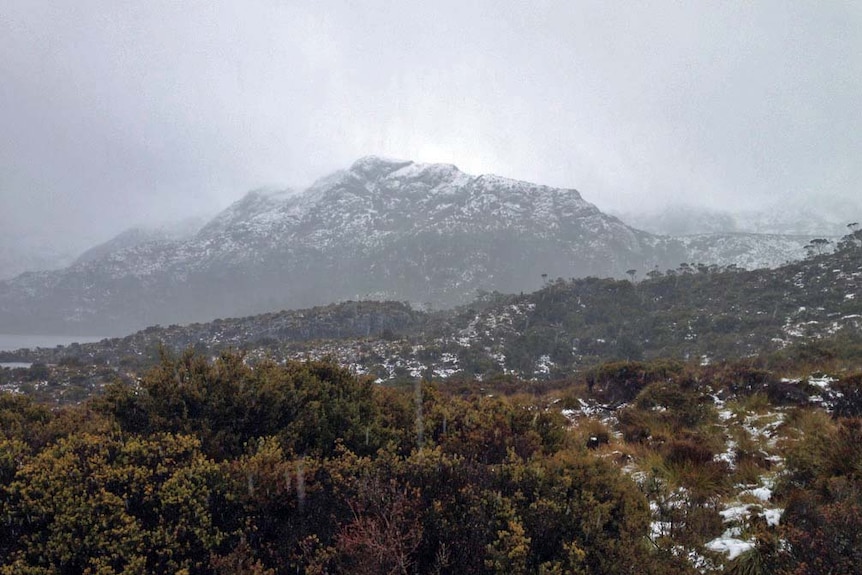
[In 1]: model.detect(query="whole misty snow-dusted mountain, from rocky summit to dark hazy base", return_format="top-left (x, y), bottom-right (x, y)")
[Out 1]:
top-left (0, 157), bottom-right (824, 335)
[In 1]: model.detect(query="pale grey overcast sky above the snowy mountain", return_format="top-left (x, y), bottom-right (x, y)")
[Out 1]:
top-left (0, 0), bottom-right (862, 248)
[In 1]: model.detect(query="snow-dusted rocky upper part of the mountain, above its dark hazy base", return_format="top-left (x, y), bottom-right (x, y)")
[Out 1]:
top-left (191, 157), bottom-right (660, 273)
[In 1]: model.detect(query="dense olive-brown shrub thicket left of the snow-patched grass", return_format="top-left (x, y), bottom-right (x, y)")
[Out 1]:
top-left (0, 353), bottom-right (686, 574)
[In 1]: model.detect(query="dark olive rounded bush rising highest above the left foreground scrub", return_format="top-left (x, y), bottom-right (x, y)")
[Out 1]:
top-left (100, 351), bottom-right (404, 458)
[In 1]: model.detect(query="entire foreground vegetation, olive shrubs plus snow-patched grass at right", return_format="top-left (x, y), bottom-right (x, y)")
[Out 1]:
top-left (0, 351), bottom-right (862, 575)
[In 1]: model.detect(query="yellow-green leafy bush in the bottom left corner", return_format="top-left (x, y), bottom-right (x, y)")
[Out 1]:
top-left (2, 433), bottom-right (230, 574)
